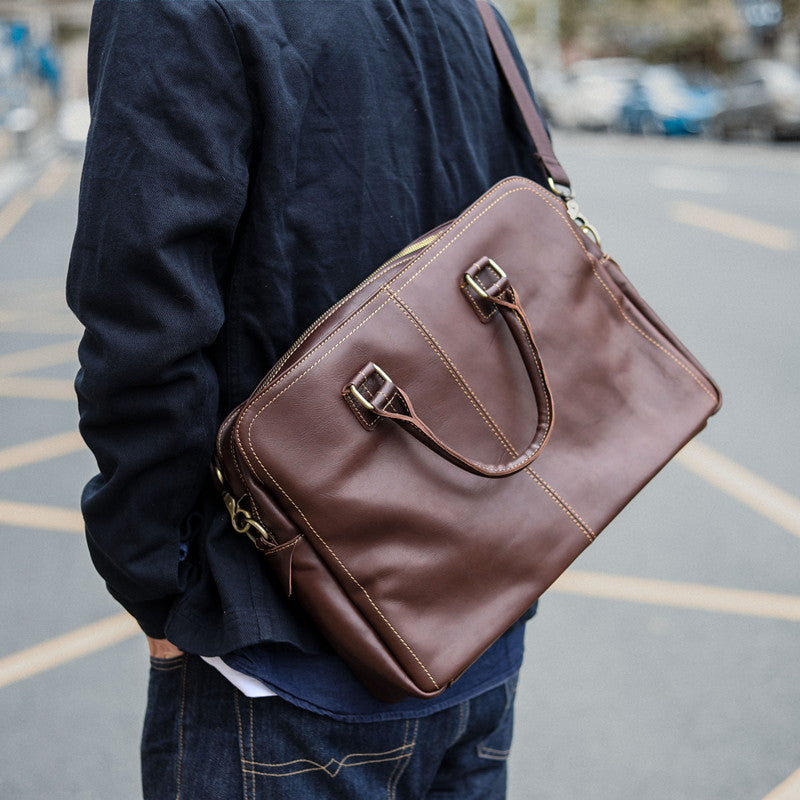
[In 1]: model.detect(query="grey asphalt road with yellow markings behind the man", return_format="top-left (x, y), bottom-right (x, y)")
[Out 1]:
top-left (0, 132), bottom-right (800, 800)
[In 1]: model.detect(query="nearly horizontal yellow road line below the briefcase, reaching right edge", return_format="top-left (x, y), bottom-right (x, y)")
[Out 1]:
top-left (550, 569), bottom-right (800, 622)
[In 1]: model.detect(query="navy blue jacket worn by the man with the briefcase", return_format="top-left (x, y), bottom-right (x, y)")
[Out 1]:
top-left (68, 0), bottom-right (542, 655)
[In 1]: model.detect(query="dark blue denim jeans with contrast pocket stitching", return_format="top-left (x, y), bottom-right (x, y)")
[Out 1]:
top-left (142, 656), bottom-right (516, 800)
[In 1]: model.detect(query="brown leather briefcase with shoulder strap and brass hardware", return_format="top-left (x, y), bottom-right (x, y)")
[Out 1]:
top-left (211, 3), bottom-right (720, 700)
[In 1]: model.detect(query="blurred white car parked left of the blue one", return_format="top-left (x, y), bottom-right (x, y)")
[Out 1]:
top-left (546, 58), bottom-right (643, 131)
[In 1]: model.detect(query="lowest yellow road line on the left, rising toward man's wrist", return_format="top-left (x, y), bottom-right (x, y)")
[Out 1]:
top-left (0, 612), bottom-right (141, 688)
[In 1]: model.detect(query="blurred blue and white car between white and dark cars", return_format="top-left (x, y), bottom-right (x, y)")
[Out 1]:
top-left (619, 64), bottom-right (719, 136)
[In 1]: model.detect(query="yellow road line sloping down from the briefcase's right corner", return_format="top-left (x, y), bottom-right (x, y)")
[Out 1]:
top-left (675, 441), bottom-right (800, 537)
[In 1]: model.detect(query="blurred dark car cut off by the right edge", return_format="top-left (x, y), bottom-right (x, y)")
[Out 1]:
top-left (710, 59), bottom-right (800, 139)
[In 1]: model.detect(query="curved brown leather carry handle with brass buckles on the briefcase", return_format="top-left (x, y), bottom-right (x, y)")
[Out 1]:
top-left (342, 258), bottom-right (553, 478)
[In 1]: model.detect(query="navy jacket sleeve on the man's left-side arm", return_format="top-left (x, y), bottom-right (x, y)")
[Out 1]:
top-left (67, 0), bottom-right (252, 638)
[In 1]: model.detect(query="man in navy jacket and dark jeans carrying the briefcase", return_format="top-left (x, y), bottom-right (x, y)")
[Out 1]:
top-left (68, 0), bottom-right (542, 800)
